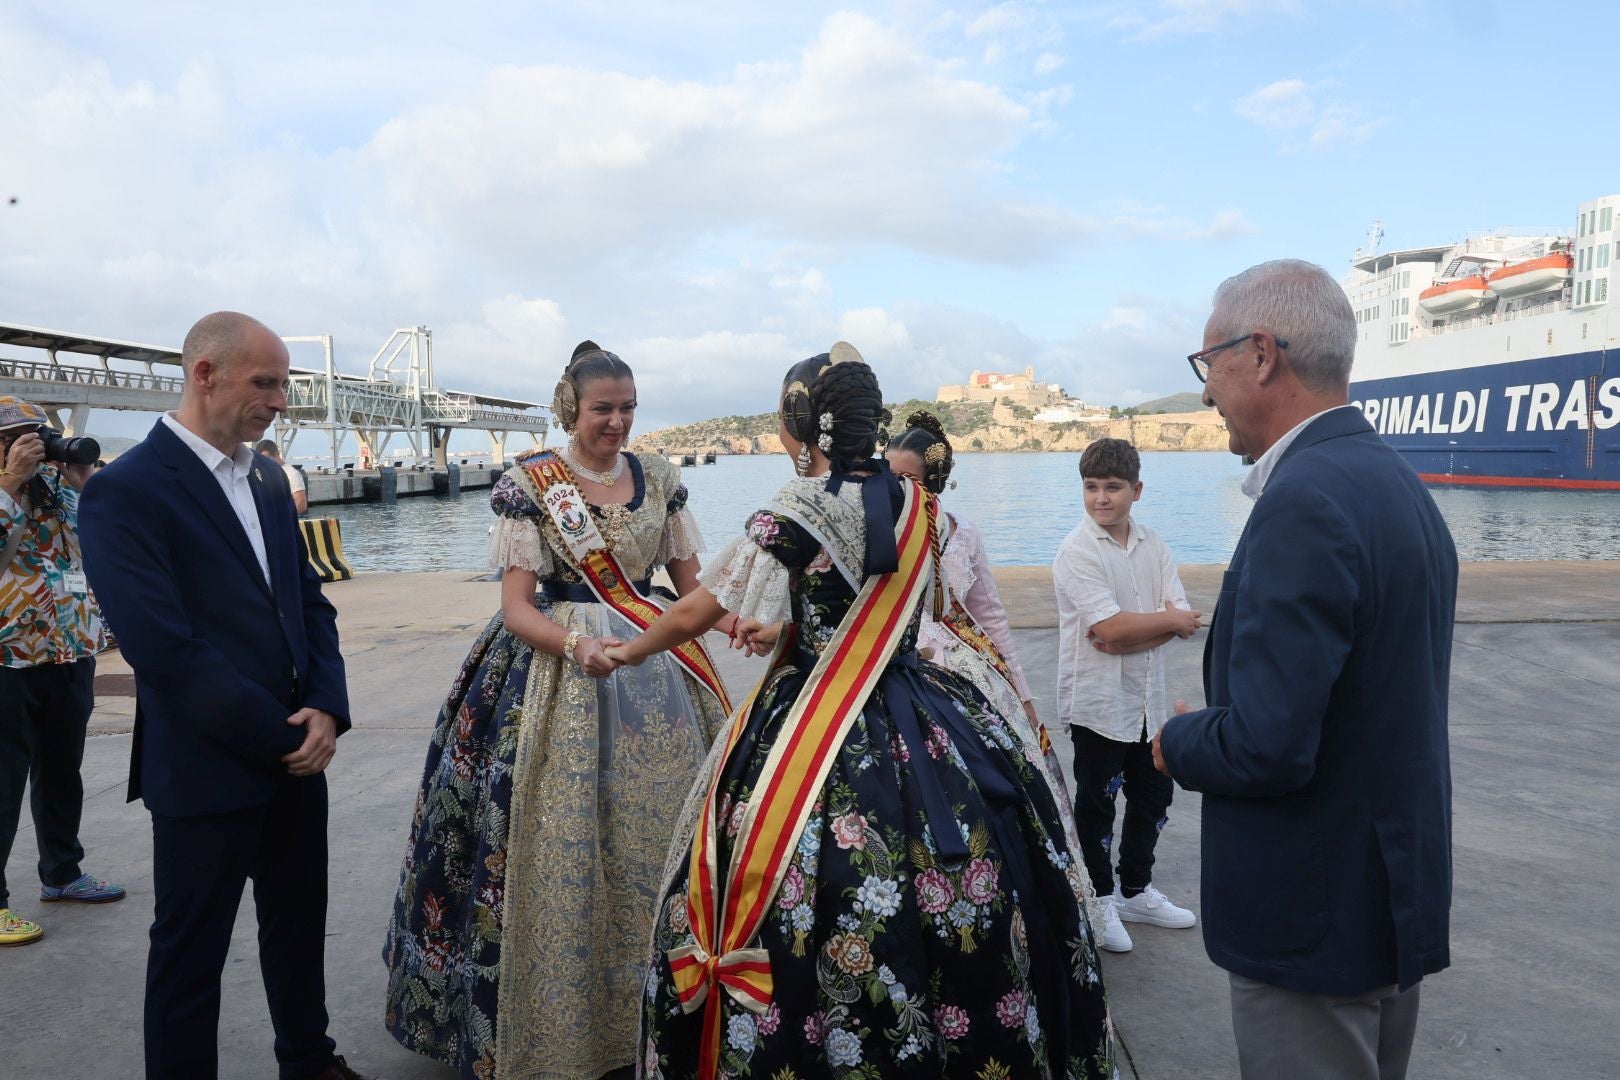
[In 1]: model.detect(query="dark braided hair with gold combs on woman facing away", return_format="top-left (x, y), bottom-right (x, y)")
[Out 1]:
top-left (782, 342), bottom-right (891, 461)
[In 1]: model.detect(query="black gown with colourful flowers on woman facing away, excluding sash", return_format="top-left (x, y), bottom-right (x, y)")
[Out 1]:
top-left (640, 478), bottom-right (1113, 1080)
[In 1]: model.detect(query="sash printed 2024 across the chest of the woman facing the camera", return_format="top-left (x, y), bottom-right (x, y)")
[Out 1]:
top-left (520, 450), bottom-right (731, 712)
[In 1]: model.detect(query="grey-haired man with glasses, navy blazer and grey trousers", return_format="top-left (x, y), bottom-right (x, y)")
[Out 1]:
top-left (1157, 261), bottom-right (1456, 1080)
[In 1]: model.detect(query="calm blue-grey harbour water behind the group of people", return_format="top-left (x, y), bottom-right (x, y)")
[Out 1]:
top-left (309, 453), bottom-right (1620, 570)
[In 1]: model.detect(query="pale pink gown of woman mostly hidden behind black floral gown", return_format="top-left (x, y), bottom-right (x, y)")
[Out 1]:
top-left (917, 512), bottom-right (1103, 929)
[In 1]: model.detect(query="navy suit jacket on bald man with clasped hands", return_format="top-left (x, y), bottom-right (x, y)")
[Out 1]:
top-left (79, 421), bottom-right (348, 818)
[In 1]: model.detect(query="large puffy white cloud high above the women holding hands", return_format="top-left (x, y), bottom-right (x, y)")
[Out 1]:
top-left (363, 15), bottom-right (1084, 264)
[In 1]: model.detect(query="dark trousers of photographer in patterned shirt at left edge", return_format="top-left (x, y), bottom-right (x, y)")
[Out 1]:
top-left (0, 656), bottom-right (96, 907)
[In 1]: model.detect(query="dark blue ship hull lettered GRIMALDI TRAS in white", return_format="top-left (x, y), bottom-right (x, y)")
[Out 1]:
top-left (1349, 350), bottom-right (1620, 491)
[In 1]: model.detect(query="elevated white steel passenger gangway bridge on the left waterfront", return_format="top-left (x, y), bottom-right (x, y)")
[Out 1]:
top-left (0, 324), bottom-right (551, 468)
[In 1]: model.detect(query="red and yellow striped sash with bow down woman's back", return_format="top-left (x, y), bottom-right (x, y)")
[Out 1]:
top-left (669, 481), bottom-right (935, 1080)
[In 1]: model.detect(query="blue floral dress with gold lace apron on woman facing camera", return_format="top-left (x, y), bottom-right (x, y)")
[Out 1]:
top-left (384, 457), bottom-right (725, 1080)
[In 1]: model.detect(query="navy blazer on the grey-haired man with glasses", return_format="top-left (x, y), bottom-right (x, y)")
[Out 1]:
top-left (1162, 408), bottom-right (1456, 996)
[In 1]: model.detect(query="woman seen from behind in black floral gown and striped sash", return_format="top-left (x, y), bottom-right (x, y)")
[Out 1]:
top-left (608, 343), bottom-right (1113, 1080)
